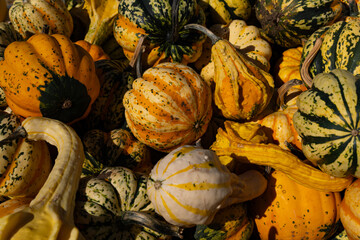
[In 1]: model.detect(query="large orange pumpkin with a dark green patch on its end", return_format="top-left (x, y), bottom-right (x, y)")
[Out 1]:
top-left (0, 34), bottom-right (100, 124)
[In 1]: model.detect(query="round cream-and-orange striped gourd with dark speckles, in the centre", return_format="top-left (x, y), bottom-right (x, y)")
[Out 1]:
top-left (123, 62), bottom-right (212, 152)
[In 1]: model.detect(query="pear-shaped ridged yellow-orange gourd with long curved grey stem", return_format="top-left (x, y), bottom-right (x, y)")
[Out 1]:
top-left (185, 24), bottom-right (274, 120)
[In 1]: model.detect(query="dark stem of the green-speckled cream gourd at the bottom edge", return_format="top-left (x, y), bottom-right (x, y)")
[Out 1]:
top-left (118, 211), bottom-right (184, 239)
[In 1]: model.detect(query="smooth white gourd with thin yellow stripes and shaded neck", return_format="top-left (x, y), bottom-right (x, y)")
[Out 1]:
top-left (147, 145), bottom-right (267, 227)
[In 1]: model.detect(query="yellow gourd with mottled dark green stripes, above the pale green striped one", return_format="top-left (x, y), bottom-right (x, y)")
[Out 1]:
top-left (301, 19), bottom-right (360, 78)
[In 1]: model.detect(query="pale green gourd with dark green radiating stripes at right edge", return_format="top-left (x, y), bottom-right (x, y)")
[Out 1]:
top-left (293, 69), bottom-right (360, 177)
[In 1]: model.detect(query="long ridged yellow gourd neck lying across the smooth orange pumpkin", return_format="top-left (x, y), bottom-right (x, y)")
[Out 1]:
top-left (210, 121), bottom-right (353, 192)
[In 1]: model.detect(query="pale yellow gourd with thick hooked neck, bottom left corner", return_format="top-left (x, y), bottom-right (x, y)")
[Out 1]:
top-left (0, 117), bottom-right (84, 240)
